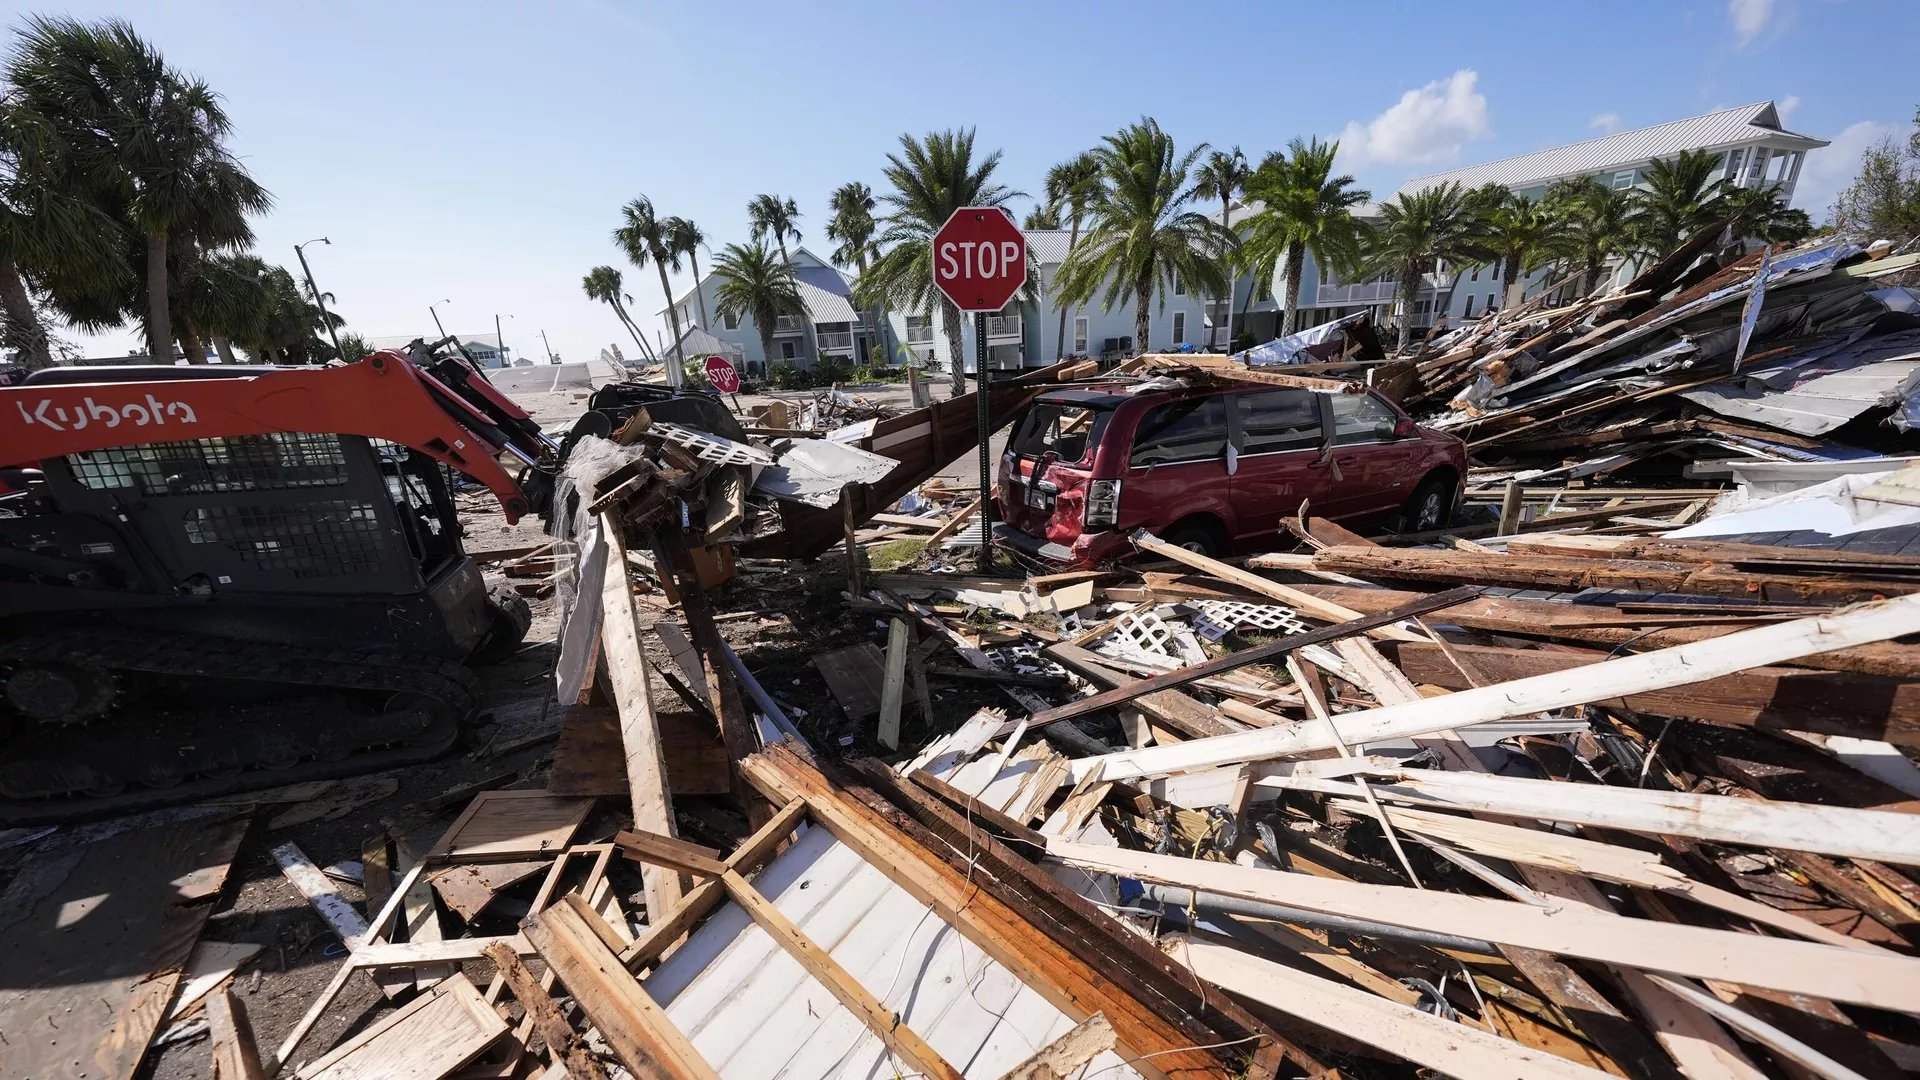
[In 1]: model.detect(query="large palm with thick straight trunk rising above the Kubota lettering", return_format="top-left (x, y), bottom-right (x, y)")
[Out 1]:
top-left (8, 15), bottom-right (273, 359)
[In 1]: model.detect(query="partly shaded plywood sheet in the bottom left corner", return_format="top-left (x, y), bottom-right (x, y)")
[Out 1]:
top-left (0, 811), bottom-right (250, 1080)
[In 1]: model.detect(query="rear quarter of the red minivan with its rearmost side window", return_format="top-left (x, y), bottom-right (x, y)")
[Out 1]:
top-left (1119, 394), bottom-right (1235, 536)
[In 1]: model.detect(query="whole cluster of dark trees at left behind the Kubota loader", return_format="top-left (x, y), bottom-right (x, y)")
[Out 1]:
top-left (0, 15), bottom-right (365, 369)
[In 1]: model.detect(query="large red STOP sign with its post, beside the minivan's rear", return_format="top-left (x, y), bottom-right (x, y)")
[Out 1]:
top-left (933, 206), bottom-right (1027, 575)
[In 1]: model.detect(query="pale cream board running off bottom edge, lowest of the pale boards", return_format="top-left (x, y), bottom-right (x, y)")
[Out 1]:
top-left (1165, 934), bottom-right (1607, 1080)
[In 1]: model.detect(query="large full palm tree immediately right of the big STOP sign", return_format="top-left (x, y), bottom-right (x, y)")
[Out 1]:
top-left (1060, 117), bottom-right (1229, 354)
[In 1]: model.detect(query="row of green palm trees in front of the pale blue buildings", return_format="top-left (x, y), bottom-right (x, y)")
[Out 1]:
top-left (586, 117), bottom-right (1812, 376)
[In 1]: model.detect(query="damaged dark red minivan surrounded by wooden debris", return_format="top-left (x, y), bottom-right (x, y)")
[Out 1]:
top-left (995, 382), bottom-right (1467, 567)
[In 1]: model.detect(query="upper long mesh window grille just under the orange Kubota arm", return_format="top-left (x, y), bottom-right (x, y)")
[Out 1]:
top-left (67, 432), bottom-right (348, 496)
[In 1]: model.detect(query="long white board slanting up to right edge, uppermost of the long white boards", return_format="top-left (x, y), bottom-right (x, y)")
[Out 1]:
top-left (1067, 594), bottom-right (1920, 782)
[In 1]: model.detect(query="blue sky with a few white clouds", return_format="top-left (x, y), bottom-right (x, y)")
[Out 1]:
top-left (8, 0), bottom-right (1920, 359)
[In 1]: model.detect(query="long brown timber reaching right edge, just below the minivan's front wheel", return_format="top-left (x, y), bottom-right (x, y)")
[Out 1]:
top-left (1313, 546), bottom-right (1920, 603)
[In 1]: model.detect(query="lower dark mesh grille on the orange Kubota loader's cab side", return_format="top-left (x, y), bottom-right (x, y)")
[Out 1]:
top-left (182, 500), bottom-right (382, 578)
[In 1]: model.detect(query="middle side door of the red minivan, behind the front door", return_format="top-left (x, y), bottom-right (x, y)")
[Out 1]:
top-left (1229, 390), bottom-right (1332, 540)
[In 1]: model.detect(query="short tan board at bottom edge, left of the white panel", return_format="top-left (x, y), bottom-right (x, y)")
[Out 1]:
top-left (522, 894), bottom-right (720, 1080)
